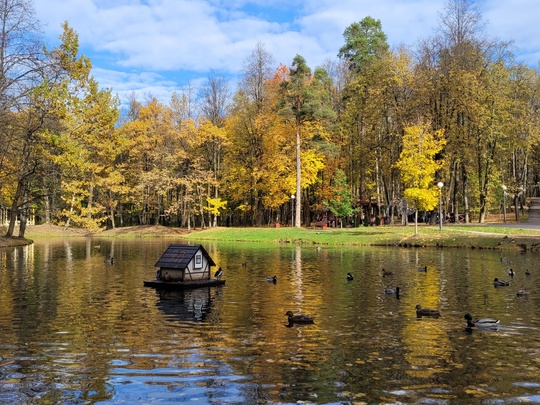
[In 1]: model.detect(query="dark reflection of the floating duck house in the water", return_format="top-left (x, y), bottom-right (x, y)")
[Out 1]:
top-left (157, 287), bottom-right (219, 322)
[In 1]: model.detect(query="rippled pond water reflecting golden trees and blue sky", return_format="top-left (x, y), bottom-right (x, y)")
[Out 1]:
top-left (0, 238), bottom-right (540, 404)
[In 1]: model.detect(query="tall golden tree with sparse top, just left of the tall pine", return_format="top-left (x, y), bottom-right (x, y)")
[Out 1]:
top-left (224, 44), bottom-right (285, 226)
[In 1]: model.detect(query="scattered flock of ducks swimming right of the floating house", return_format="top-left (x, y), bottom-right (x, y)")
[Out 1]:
top-left (282, 258), bottom-right (531, 329)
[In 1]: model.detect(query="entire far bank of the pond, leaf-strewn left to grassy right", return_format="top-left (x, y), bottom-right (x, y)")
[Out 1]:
top-left (0, 224), bottom-right (540, 250)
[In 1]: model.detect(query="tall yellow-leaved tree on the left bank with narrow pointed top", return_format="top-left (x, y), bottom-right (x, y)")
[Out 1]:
top-left (41, 23), bottom-right (122, 231)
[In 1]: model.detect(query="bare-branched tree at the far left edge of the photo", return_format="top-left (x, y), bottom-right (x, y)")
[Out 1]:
top-left (0, 0), bottom-right (44, 237)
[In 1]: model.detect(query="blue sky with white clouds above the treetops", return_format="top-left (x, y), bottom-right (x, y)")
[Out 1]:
top-left (34, 0), bottom-right (540, 108)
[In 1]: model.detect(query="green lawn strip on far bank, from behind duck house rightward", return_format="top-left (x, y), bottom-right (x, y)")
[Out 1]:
top-left (184, 225), bottom-right (540, 250)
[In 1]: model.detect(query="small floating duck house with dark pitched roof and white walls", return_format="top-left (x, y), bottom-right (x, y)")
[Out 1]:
top-left (155, 245), bottom-right (216, 282)
